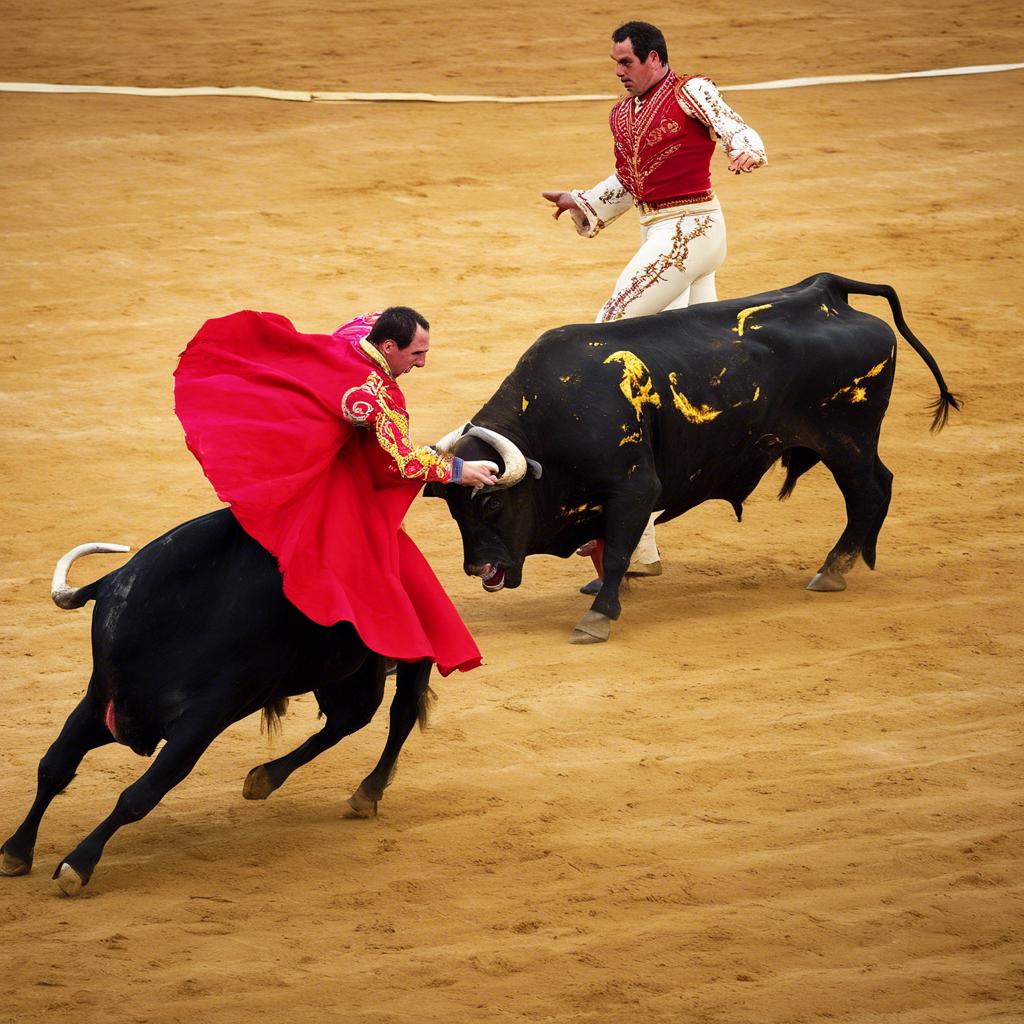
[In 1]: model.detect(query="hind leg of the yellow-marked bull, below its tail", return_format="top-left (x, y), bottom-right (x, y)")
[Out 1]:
top-left (807, 443), bottom-right (892, 593)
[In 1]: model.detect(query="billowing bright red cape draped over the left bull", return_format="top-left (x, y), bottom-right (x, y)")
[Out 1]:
top-left (174, 310), bottom-right (480, 675)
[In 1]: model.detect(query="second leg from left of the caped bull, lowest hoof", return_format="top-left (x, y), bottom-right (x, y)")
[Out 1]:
top-left (53, 708), bottom-right (223, 896)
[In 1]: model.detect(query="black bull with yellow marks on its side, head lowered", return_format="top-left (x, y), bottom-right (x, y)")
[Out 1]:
top-left (427, 273), bottom-right (959, 642)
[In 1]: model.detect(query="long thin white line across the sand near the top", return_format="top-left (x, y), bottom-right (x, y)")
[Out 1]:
top-left (0, 63), bottom-right (1024, 103)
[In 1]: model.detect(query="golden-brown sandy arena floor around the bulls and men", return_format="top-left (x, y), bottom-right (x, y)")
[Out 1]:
top-left (0, 0), bottom-right (1024, 1024)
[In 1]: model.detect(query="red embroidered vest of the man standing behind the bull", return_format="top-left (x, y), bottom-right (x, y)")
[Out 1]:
top-left (608, 71), bottom-right (715, 203)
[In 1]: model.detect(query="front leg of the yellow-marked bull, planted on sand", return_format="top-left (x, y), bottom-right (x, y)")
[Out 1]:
top-left (569, 471), bottom-right (662, 644)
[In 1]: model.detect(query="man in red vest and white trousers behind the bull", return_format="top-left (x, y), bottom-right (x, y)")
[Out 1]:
top-left (544, 22), bottom-right (768, 575)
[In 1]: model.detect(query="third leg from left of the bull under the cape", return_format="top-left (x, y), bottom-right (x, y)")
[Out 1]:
top-left (242, 654), bottom-right (385, 800)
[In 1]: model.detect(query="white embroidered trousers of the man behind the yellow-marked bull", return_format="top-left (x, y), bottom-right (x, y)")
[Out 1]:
top-left (597, 203), bottom-right (726, 565)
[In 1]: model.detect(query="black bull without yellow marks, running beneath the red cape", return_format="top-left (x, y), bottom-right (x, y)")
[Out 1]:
top-left (0, 509), bottom-right (432, 895)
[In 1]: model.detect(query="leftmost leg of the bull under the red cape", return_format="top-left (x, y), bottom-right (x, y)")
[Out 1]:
top-left (0, 687), bottom-right (114, 876)
